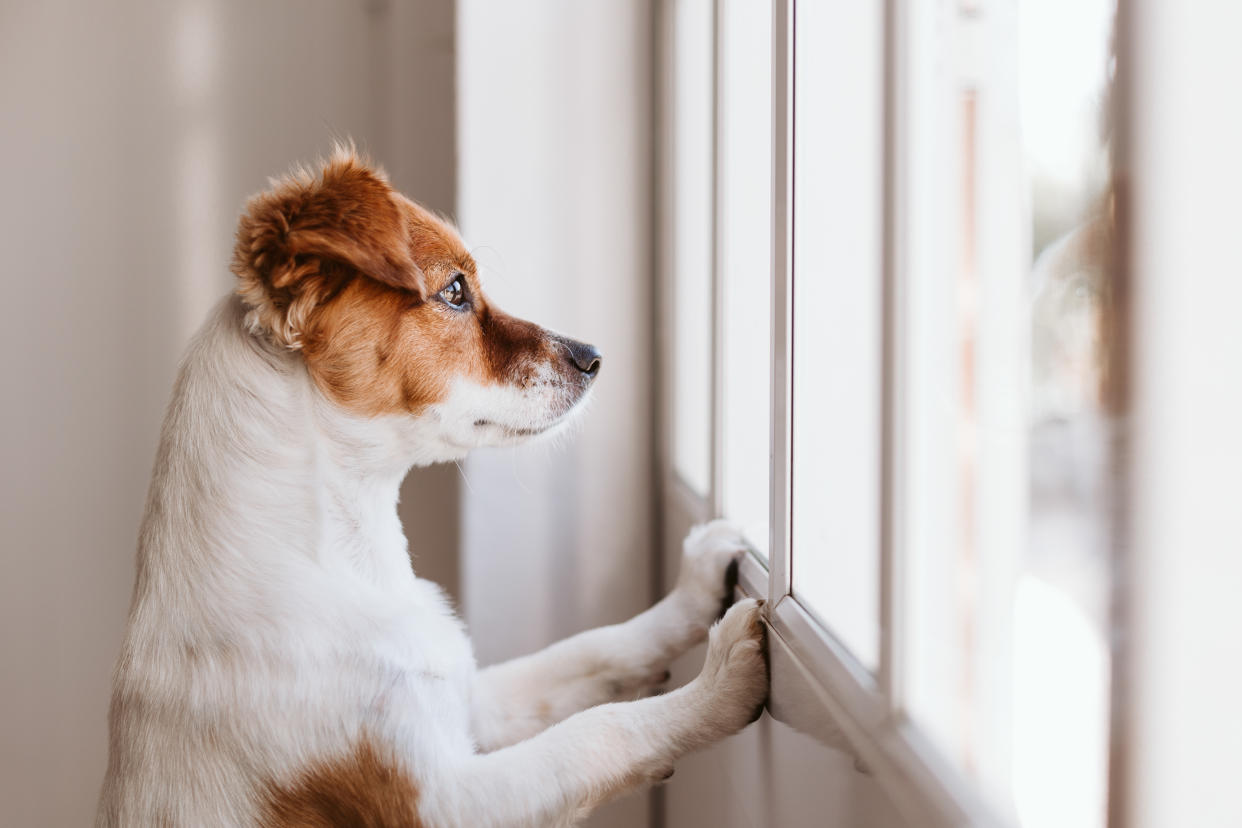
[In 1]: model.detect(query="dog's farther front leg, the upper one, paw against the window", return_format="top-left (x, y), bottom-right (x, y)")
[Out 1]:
top-left (472, 520), bottom-right (744, 750)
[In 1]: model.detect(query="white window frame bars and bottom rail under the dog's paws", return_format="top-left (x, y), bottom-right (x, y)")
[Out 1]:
top-left (658, 0), bottom-right (1122, 826)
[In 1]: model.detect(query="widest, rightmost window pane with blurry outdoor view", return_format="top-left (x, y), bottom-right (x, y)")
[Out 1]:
top-left (900, 0), bottom-right (1114, 827)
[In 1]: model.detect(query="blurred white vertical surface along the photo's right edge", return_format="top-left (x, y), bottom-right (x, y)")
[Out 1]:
top-left (1132, 0), bottom-right (1242, 828)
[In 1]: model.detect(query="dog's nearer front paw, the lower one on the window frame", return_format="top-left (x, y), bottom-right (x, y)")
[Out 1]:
top-left (694, 598), bottom-right (768, 736)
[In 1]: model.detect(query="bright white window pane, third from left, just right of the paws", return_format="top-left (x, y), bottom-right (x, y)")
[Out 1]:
top-left (790, 2), bottom-right (883, 668)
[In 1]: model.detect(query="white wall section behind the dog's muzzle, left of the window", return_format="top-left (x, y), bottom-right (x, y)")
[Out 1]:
top-left (457, 0), bottom-right (655, 828)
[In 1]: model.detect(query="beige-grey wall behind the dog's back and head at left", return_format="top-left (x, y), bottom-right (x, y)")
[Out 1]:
top-left (0, 0), bottom-right (458, 826)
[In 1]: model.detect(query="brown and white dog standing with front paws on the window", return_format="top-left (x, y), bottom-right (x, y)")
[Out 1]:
top-left (97, 146), bottom-right (768, 828)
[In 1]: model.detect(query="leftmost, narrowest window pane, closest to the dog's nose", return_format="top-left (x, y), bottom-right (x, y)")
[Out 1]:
top-left (671, 0), bottom-right (713, 495)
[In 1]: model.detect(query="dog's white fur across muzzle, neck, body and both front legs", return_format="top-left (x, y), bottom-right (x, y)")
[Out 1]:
top-left (97, 298), bottom-right (766, 828)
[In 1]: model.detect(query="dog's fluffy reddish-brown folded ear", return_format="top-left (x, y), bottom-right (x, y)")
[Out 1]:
top-left (232, 148), bottom-right (425, 348)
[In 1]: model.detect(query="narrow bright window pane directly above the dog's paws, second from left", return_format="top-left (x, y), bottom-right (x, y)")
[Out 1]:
top-left (718, 0), bottom-right (773, 552)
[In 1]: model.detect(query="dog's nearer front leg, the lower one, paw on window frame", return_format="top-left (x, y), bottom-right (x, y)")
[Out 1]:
top-left (432, 600), bottom-right (768, 828)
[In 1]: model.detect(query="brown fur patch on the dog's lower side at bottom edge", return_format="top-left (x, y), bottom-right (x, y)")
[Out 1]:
top-left (260, 739), bottom-right (422, 828)
